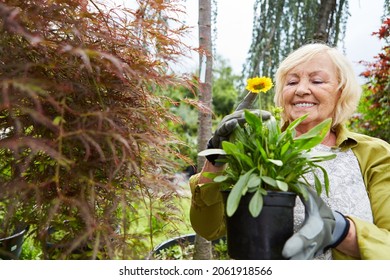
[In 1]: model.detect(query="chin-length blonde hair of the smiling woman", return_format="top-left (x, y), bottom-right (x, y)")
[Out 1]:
top-left (274, 43), bottom-right (362, 127)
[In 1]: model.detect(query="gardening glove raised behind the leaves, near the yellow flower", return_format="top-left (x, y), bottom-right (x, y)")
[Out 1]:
top-left (206, 92), bottom-right (271, 166)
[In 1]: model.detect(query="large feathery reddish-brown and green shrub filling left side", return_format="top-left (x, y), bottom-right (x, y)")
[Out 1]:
top-left (0, 0), bottom-right (195, 259)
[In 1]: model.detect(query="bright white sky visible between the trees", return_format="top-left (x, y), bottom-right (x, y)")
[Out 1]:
top-left (184, 0), bottom-right (384, 83)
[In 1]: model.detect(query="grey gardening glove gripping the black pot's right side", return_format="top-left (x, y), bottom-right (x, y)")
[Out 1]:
top-left (282, 190), bottom-right (350, 260)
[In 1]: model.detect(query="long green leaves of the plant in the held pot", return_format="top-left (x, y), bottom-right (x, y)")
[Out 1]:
top-left (200, 110), bottom-right (335, 217)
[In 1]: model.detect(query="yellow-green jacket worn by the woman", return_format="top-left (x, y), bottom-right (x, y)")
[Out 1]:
top-left (190, 126), bottom-right (390, 260)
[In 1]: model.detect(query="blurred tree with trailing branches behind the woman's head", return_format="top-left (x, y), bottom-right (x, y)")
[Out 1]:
top-left (240, 0), bottom-right (348, 109)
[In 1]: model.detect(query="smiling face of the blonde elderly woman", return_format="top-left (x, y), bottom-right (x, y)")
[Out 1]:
top-left (282, 53), bottom-right (340, 133)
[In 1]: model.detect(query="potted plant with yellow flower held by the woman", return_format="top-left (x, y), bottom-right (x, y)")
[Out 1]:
top-left (200, 77), bottom-right (335, 259)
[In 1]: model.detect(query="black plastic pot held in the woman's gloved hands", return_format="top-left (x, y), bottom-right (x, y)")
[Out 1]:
top-left (222, 191), bottom-right (296, 260)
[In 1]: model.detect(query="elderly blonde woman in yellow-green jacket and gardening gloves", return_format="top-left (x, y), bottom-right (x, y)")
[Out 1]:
top-left (190, 43), bottom-right (390, 259)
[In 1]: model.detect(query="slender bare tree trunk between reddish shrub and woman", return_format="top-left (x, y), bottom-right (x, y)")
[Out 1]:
top-left (193, 0), bottom-right (213, 260)
